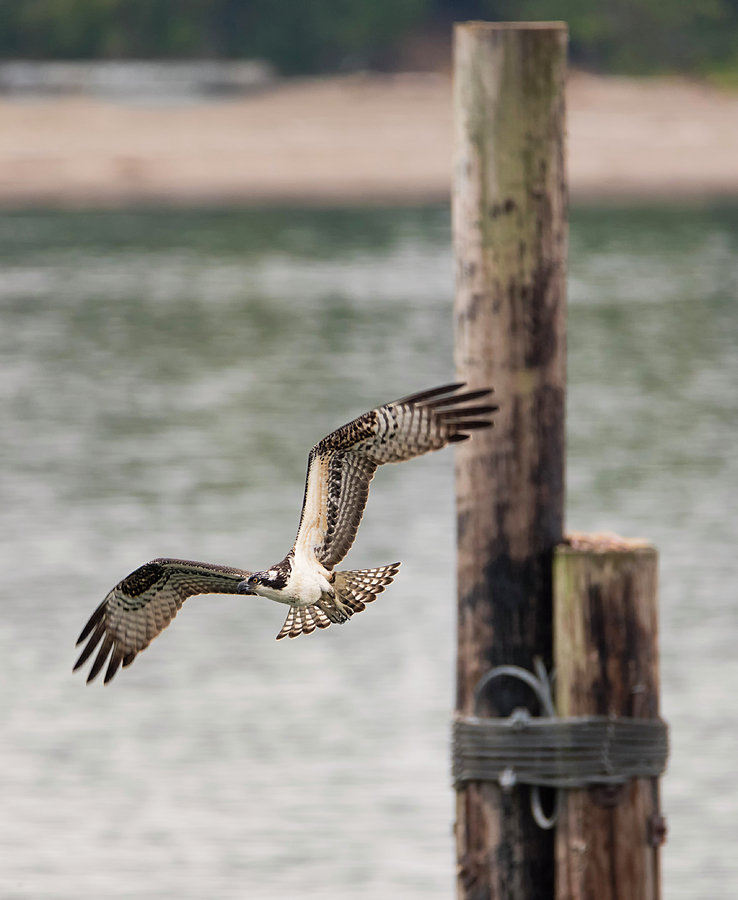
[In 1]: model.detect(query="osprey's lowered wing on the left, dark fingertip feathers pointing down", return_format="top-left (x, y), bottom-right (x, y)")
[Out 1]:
top-left (74, 559), bottom-right (251, 684)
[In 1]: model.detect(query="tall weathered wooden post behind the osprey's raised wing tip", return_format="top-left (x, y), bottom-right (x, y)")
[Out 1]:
top-left (453, 22), bottom-right (567, 900)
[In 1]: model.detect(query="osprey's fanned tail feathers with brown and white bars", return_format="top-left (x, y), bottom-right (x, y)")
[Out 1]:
top-left (277, 563), bottom-right (400, 641)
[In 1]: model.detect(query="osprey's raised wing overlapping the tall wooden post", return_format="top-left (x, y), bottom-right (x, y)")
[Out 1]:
top-left (293, 382), bottom-right (497, 569)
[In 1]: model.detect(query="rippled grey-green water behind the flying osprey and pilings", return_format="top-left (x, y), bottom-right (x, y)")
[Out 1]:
top-left (0, 209), bottom-right (738, 900)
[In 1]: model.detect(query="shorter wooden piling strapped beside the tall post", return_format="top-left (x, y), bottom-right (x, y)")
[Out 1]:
top-left (554, 535), bottom-right (664, 900)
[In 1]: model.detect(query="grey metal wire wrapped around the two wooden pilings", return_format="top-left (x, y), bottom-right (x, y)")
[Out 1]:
top-left (453, 660), bottom-right (669, 828)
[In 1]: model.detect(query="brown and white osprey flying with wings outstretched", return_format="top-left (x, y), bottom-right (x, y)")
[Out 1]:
top-left (74, 383), bottom-right (497, 683)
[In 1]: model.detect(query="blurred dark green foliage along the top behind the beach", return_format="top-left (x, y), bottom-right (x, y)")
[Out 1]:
top-left (0, 0), bottom-right (738, 74)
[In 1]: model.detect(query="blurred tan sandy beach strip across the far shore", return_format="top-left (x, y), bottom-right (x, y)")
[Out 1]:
top-left (0, 73), bottom-right (738, 208)
